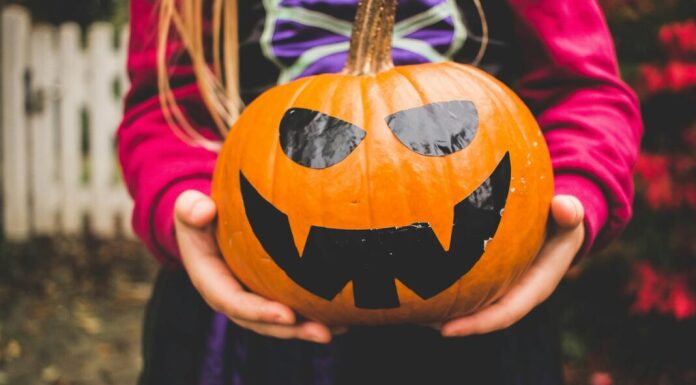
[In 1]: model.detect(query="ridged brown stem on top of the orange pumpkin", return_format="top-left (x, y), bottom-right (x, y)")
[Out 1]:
top-left (343, 0), bottom-right (396, 75)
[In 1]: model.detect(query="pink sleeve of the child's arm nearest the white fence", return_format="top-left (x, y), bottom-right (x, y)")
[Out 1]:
top-left (117, 0), bottom-right (216, 264)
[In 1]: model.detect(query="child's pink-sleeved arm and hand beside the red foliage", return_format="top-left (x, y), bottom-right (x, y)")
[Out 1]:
top-left (442, 0), bottom-right (642, 336)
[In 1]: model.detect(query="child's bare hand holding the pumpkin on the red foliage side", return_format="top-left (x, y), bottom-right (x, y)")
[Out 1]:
top-left (440, 195), bottom-right (585, 337)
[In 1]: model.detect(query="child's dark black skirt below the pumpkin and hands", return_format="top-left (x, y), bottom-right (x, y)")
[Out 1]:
top-left (139, 269), bottom-right (563, 385)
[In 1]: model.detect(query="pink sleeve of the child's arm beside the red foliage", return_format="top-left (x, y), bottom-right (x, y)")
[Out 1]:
top-left (509, 0), bottom-right (642, 254)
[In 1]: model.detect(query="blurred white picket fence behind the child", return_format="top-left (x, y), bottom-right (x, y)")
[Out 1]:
top-left (0, 6), bottom-right (132, 240)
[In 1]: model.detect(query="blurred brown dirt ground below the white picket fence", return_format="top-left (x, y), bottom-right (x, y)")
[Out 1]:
top-left (0, 239), bottom-right (156, 385)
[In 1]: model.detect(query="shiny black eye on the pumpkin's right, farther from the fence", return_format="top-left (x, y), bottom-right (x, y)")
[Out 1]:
top-left (385, 100), bottom-right (479, 156)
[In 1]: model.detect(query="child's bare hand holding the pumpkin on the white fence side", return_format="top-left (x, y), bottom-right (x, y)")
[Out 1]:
top-left (174, 190), bottom-right (338, 343)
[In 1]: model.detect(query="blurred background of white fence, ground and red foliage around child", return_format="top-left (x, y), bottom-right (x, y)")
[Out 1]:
top-left (0, 0), bottom-right (696, 385)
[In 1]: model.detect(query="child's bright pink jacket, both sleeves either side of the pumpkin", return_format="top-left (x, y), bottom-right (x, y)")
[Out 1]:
top-left (118, 0), bottom-right (642, 264)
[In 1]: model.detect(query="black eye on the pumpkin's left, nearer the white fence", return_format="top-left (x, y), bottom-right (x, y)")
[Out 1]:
top-left (280, 108), bottom-right (365, 169)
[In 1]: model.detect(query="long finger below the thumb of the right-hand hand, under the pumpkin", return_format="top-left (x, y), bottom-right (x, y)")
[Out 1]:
top-left (441, 222), bottom-right (582, 336)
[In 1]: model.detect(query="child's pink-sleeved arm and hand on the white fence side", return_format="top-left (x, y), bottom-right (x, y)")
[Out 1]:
top-left (118, 0), bottom-right (331, 342)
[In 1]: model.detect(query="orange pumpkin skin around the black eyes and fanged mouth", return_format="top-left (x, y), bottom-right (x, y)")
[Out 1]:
top-left (212, 62), bottom-right (553, 325)
